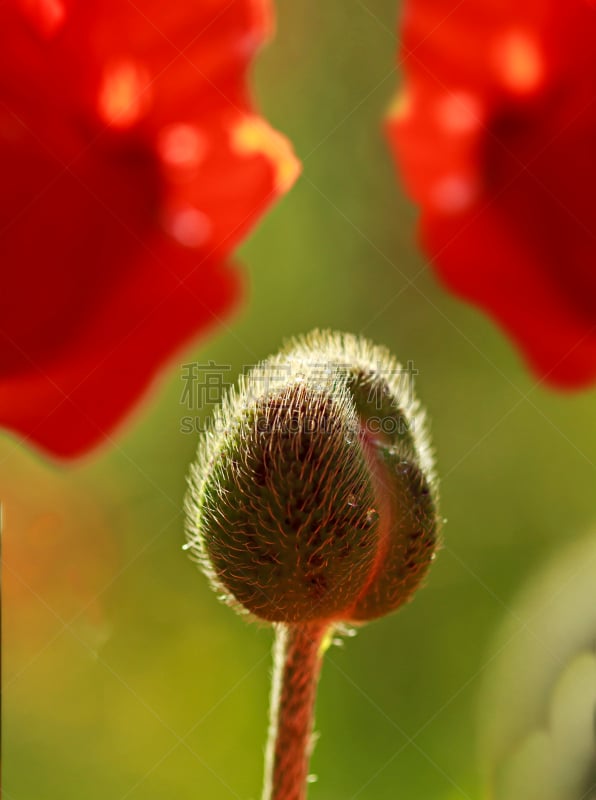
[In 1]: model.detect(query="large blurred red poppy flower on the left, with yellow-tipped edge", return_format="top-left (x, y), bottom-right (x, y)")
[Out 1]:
top-left (0, 0), bottom-right (298, 456)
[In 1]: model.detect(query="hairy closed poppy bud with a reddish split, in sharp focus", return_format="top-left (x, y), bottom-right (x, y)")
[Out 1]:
top-left (187, 331), bottom-right (438, 623)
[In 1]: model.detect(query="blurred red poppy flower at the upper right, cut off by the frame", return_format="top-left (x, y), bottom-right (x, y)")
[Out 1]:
top-left (389, 0), bottom-right (596, 387)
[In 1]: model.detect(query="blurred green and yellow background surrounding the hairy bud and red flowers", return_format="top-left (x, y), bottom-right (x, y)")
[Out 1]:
top-left (0, 0), bottom-right (596, 800)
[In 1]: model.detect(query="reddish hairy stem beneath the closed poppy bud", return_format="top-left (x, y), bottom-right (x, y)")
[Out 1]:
top-left (263, 623), bottom-right (328, 800)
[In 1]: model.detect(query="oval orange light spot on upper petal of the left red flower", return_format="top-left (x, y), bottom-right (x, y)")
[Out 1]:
top-left (98, 60), bottom-right (149, 128)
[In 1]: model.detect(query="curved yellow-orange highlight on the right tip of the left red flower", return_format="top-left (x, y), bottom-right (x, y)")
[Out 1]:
top-left (232, 116), bottom-right (302, 192)
